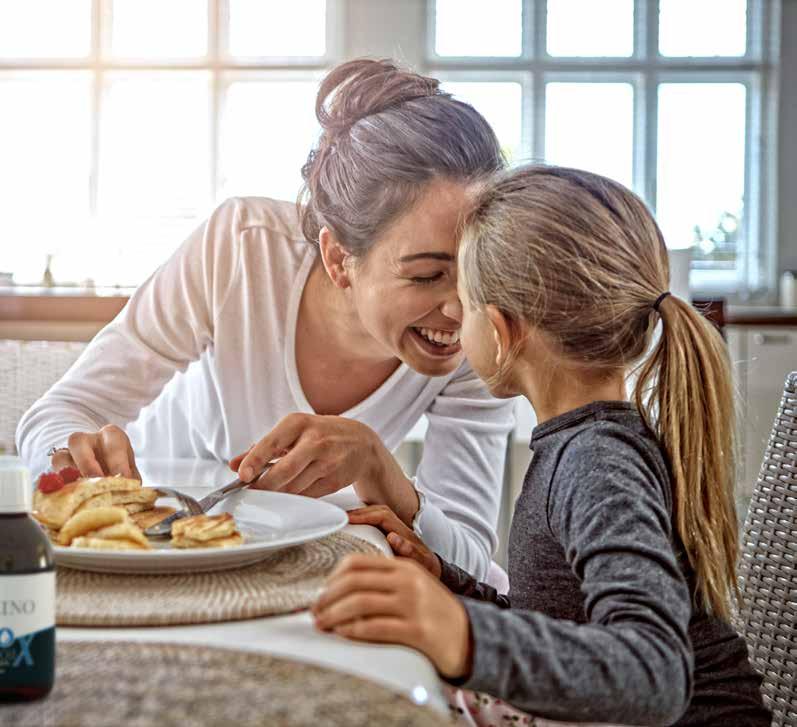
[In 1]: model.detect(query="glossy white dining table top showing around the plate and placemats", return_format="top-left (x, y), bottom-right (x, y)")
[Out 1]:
top-left (9, 459), bottom-right (448, 717)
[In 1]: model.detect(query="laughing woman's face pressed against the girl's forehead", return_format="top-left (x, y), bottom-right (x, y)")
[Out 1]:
top-left (349, 180), bottom-right (470, 376)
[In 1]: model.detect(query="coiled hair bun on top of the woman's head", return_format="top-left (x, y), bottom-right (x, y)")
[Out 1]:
top-left (315, 58), bottom-right (449, 139)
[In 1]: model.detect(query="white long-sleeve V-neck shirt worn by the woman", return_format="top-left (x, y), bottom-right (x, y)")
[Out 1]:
top-left (17, 198), bottom-right (513, 578)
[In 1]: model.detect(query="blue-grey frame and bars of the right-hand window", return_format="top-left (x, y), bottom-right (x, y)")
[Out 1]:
top-left (424, 0), bottom-right (781, 301)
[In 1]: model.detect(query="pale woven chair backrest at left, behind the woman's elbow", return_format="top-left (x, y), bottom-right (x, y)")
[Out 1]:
top-left (0, 340), bottom-right (86, 454)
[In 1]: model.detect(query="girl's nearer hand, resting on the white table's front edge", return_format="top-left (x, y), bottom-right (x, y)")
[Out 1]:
top-left (311, 555), bottom-right (471, 679)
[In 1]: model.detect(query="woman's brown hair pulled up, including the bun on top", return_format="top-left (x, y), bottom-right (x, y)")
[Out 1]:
top-left (297, 59), bottom-right (504, 255)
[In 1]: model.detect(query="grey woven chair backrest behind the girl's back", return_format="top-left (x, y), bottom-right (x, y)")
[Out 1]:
top-left (737, 372), bottom-right (797, 727)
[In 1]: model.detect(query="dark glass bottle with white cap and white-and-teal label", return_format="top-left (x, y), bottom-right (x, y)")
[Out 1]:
top-left (0, 458), bottom-right (55, 702)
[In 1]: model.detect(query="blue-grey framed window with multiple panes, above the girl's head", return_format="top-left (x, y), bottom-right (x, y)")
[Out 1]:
top-left (426, 0), bottom-right (777, 296)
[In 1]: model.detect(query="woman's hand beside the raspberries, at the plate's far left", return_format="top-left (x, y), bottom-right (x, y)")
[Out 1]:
top-left (50, 424), bottom-right (141, 480)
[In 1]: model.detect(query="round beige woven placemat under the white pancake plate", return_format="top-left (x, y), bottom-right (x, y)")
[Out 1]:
top-left (56, 533), bottom-right (380, 626)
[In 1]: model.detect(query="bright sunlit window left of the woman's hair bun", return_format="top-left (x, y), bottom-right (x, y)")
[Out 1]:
top-left (0, 0), bottom-right (337, 285)
